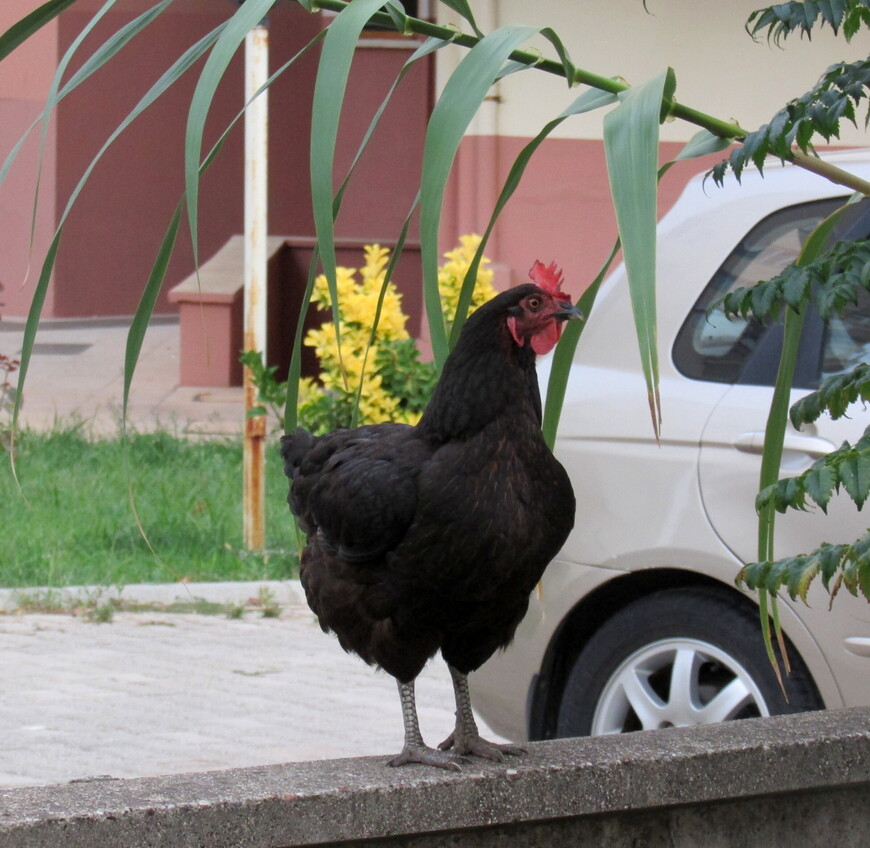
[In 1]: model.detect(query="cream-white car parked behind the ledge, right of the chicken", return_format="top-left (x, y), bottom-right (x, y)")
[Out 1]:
top-left (471, 151), bottom-right (870, 740)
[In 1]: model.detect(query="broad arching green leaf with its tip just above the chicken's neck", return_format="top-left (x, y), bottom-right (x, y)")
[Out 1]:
top-left (420, 27), bottom-right (537, 368)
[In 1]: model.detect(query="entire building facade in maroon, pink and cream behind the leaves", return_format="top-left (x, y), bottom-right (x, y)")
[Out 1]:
top-left (0, 0), bottom-right (866, 342)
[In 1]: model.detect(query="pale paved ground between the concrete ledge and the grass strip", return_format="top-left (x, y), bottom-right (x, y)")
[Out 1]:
top-left (0, 581), bottom-right (510, 788)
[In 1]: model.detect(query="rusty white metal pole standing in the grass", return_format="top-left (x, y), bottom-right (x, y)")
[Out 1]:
top-left (242, 22), bottom-right (269, 551)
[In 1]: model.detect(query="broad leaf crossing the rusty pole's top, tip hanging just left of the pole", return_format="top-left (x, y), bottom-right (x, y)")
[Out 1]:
top-left (184, 0), bottom-right (277, 273)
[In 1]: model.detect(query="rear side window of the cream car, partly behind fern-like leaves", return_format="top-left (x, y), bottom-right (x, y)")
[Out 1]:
top-left (673, 197), bottom-right (852, 385)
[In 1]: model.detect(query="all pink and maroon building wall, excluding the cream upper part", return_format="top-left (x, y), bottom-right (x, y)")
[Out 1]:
top-left (0, 0), bottom-right (717, 372)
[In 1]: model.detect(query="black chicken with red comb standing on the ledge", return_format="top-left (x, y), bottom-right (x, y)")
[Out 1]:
top-left (281, 262), bottom-right (580, 769)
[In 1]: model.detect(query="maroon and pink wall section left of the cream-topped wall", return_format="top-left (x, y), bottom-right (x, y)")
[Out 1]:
top-left (0, 0), bottom-right (433, 328)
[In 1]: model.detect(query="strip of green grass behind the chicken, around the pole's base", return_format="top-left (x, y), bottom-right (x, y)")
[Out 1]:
top-left (0, 427), bottom-right (297, 588)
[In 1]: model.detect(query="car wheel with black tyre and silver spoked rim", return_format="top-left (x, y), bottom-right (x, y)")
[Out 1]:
top-left (556, 588), bottom-right (824, 736)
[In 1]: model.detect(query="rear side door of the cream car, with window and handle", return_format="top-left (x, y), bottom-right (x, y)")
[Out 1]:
top-left (675, 201), bottom-right (870, 704)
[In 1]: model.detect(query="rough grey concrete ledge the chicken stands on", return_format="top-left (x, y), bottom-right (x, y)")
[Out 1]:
top-left (0, 708), bottom-right (870, 848)
